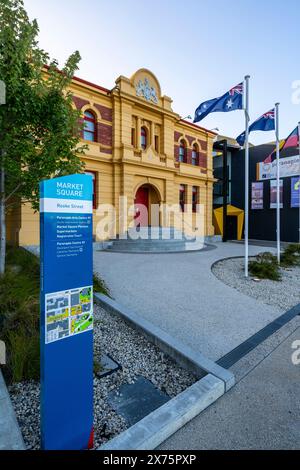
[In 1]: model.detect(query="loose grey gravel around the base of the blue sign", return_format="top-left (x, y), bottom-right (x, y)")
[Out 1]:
top-left (9, 305), bottom-right (196, 449)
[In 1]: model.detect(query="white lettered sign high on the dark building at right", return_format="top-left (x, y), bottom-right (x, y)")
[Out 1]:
top-left (256, 155), bottom-right (300, 180)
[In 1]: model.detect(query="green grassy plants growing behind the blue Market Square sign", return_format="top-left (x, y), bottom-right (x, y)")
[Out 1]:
top-left (0, 247), bottom-right (109, 383)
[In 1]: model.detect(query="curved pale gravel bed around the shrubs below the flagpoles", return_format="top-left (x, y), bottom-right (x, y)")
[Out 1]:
top-left (212, 258), bottom-right (300, 312)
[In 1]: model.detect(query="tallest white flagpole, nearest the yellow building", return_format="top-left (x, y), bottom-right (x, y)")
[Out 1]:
top-left (244, 75), bottom-right (250, 277)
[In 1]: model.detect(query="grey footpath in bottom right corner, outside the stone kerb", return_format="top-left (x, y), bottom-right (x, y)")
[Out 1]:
top-left (160, 324), bottom-right (300, 450)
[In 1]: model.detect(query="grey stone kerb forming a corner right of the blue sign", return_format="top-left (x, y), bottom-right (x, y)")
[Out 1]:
top-left (94, 293), bottom-right (235, 451)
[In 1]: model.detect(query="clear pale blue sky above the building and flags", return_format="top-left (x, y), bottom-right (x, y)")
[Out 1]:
top-left (24, 0), bottom-right (300, 144)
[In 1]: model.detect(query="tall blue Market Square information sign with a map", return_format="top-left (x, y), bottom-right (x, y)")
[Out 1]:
top-left (40, 174), bottom-right (93, 450)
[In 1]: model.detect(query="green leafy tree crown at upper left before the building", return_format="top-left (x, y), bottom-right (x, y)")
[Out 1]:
top-left (0, 0), bottom-right (85, 209)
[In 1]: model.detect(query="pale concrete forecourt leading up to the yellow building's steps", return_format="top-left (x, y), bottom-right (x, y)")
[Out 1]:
top-left (94, 243), bottom-right (282, 361)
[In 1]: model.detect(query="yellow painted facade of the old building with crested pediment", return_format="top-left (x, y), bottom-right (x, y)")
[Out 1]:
top-left (7, 69), bottom-right (215, 245)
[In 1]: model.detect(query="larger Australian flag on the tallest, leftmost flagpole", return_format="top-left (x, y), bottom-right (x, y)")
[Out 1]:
top-left (194, 82), bottom-right (244, 122)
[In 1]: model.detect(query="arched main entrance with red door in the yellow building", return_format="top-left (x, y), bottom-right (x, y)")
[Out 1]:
top-left (134, 184), bottom-right (160, 227)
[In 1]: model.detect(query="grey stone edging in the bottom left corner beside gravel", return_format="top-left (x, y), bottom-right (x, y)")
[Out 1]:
top-left (0, 369), bottom-right (25, 450)
